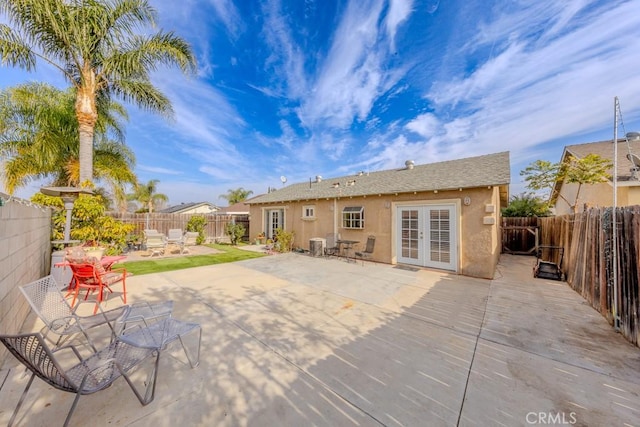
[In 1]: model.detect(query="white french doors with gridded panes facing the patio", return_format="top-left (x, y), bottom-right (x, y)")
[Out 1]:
top-left (396, 205), bottom-right (458, 271)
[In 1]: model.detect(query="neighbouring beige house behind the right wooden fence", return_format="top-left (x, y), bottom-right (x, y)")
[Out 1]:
top-left (550, 132), bottom-right (640, 215)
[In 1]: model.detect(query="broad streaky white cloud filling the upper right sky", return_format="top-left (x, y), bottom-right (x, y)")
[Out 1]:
top-left (427, 2), bottom-right (640, 163)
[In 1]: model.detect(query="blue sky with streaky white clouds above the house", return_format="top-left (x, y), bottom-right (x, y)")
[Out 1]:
top-left (0, 0), bottom-right (640, 206)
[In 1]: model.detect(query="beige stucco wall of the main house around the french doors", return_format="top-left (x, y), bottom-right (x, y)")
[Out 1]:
top-left (249, 187), bottom-right (500, 278)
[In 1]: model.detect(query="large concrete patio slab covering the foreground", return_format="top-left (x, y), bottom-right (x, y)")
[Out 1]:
top-left (0, 254), bottom-right (640, 427)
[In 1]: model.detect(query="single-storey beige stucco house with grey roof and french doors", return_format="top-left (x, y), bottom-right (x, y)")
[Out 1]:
top-left (247, 152), bottom-right (510, 278)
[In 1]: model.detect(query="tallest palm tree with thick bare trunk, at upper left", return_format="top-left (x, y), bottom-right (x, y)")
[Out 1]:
top-left (0, 0), bottom-right (196, 182)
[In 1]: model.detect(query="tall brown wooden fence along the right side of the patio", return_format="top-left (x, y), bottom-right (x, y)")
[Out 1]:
top-left (503, 210), bottom-right (640, 345)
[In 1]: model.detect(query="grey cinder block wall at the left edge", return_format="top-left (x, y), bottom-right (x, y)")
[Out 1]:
top-left (0, 193), bottom-right (51, 366)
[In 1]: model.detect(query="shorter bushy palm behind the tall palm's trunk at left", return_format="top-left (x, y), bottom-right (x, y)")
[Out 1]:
top-left (0, 83), bottom-right (137, 209)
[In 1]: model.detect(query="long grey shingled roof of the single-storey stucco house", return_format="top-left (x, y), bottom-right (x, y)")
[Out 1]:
top-left (246, 152), bottom-right (511, 204)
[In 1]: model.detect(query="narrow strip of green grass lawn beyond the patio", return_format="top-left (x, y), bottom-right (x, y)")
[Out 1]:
top-left (116, 245), bottom-right (265, 276)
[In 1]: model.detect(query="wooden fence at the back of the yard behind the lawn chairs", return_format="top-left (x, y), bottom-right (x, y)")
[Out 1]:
top-left (108, 212), bottom-right (249, 242)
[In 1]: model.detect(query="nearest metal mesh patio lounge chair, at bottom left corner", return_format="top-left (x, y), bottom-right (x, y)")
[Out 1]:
top-left (0, 332), bottom-right (159, 426)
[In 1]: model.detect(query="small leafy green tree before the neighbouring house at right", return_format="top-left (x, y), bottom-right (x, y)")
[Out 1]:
top-left (520, 154), bottom-right (613, 212)
